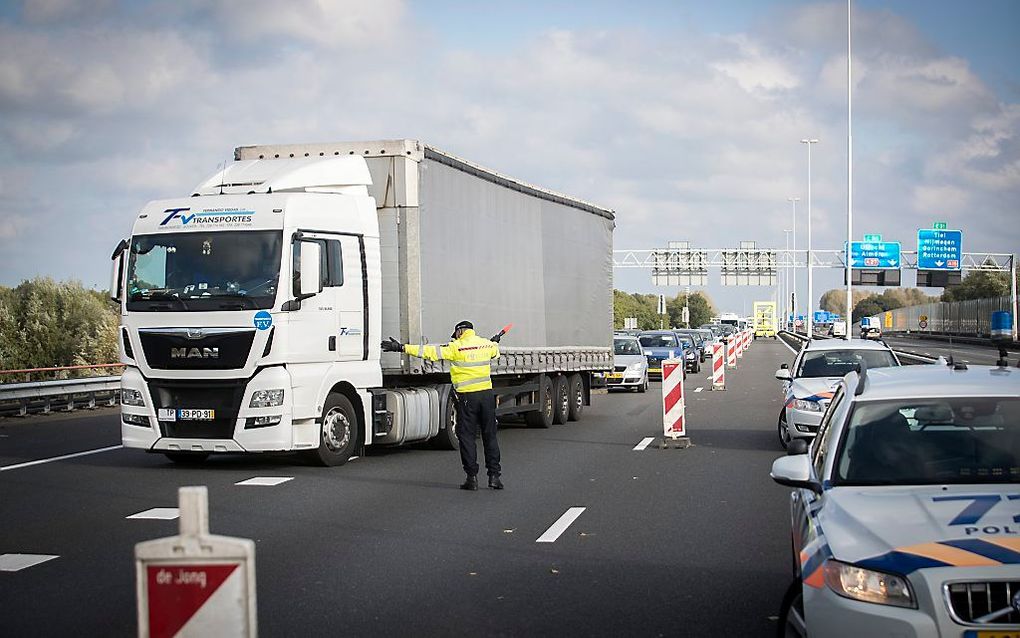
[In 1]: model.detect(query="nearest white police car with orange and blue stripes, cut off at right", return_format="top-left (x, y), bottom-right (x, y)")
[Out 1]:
top-left (771, 365), bottom-right (1020, 638)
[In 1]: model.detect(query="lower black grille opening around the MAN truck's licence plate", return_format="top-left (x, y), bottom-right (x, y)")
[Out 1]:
top-left (149, 379), bottom-right (248, 439)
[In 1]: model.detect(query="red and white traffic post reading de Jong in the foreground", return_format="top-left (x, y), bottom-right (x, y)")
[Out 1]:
top-left (135, 486), bottom-right (258, 638)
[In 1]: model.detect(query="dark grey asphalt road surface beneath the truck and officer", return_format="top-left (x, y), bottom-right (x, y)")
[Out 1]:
top-left (0, 341), bottom-right (793, 636)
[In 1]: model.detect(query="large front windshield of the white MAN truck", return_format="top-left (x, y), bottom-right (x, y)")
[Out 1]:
top-left (128, 231), bottom-right (283, 311)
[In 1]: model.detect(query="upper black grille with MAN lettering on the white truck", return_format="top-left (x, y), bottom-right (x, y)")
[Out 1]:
top-left (138, 328), bottom-right (255, 370)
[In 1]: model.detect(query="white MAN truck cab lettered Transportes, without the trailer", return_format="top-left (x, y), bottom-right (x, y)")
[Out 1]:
top-left (111, 157), bottom-right (381, 464)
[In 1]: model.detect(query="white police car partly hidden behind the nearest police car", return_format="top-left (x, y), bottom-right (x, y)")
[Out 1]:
top-left (775, 339), bottom-right (900, 449)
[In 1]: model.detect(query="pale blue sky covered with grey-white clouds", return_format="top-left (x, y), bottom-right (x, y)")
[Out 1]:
top-left (0, 0), bottom-right (1020, 314)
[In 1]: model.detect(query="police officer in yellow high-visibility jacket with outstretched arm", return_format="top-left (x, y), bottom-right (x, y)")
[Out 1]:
top-left (381, 322), bottom-right (503, 490)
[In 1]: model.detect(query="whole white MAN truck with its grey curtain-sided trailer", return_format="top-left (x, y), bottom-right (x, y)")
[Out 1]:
top-left (111, 140), bottom-right (615, 465)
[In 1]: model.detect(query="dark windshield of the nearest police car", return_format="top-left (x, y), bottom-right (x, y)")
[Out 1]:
top-left (834, 397), bottom-right (1020, 485)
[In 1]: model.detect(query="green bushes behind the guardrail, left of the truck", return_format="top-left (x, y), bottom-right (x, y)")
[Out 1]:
top-left (0, 277), bottom-right (119, 375)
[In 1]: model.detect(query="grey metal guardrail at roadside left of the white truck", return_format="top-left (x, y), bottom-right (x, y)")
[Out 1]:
top-left (0, 377), bottom-right (120, 416)
